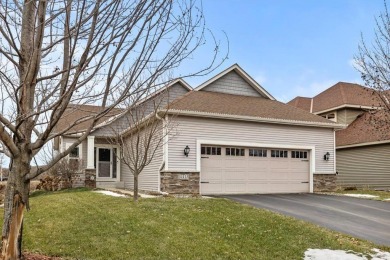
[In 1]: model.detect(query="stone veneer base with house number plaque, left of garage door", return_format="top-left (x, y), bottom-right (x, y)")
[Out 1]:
top-left (160, 171), bottom-right (200, 195)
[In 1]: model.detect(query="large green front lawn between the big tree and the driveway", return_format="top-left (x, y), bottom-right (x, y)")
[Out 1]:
top-left (1, 189), bottom-right (389, 259)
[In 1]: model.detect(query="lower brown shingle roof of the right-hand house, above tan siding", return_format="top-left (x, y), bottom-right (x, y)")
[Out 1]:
top-left (336, 110), bottom-right (390, 148)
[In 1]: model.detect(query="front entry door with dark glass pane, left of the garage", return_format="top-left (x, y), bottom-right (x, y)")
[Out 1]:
top-left (97, 148), bottom-right (117, 179)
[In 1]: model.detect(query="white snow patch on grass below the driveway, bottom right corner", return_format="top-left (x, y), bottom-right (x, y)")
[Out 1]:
top-left (304, 248), bottom-right (390, 260)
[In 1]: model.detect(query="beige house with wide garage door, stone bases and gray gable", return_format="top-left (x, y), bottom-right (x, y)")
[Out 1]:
top-left (54, 65), bottom-right (341, 194)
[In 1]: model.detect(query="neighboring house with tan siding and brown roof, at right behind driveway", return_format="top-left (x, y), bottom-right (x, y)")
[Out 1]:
top-left (288, 82), bottom-right (390, 189)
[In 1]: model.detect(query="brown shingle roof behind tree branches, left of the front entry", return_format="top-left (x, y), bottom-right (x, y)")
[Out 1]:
top-left (54, 104), bottom-right (123, 133)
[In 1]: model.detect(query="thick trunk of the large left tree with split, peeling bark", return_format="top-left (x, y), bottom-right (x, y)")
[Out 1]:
top-left (1, 158), bottom-right (30, 260)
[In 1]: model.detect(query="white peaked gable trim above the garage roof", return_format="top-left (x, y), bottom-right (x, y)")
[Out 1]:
top-left (195, 64), bottom-right (275, 100)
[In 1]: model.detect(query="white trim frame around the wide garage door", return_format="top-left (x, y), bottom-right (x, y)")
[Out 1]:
top-left (196, 139), bottom-right (315, 192)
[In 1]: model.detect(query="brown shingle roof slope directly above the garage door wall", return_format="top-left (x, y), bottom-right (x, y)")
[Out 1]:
top-left (169, 91), bottom-right (334, 124)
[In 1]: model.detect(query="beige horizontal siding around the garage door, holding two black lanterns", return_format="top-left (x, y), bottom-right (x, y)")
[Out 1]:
top-left (168, 117), bottom-right (335, 173)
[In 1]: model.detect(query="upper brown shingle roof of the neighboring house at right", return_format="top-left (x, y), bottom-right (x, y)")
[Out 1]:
top-left (312, 82), bottom-right (380, 113)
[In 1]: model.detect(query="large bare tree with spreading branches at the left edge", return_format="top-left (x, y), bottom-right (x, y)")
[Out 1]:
top-left (0, 0), bottom-right (225, 259)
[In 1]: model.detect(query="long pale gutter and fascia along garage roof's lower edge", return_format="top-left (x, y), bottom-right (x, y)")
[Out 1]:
top-left (168, 109), bottom-right (346, 129)
